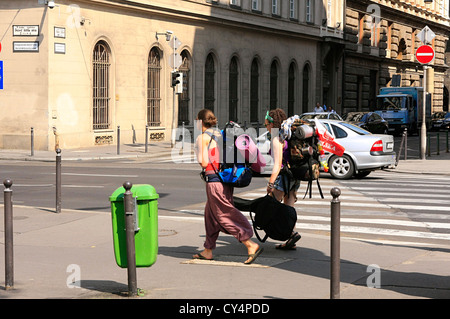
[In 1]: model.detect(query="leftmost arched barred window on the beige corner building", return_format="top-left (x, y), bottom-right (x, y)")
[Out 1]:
top-left (92, 41), bottom-right (111, 130)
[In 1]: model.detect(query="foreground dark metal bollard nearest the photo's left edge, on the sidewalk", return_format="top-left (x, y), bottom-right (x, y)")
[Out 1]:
top-left (3, 179), bottom-right (14, 290)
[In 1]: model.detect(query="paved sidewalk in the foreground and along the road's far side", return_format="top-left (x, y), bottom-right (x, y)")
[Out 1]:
top-left (0, 142), bottom-right (450, 299)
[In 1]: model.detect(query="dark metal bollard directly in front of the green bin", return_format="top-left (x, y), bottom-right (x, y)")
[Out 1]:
top-left (123, 182), bottom-right (137, 297)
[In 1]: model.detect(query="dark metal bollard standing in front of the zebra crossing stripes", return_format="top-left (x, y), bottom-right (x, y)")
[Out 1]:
top-left (330, 187), bottom-right (341, 299)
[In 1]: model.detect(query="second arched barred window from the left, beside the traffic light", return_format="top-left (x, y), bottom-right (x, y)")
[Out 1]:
top-left (147, 47), bottom-right (161, 126)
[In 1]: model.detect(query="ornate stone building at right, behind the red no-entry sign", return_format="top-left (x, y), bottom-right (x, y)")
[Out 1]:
top-left (343, 0), bottom-right (449, 112)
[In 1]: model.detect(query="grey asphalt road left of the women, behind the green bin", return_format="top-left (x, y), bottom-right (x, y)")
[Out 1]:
top-left (0, 160), bottom-right (267, 215)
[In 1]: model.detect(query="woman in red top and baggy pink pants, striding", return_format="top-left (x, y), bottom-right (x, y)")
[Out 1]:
top-left (192, 109), bottom-right (263, 264)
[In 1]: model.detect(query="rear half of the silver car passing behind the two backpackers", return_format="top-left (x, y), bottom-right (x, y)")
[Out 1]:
top-left (320, 120), bottom-right (395, 179)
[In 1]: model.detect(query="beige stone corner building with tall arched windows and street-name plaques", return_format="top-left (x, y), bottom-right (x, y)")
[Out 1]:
top-left (0, 0), bottom-right (344, 150)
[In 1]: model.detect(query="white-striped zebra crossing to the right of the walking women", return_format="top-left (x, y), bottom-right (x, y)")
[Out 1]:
top-left (236, 171), bottom-right (450, 245)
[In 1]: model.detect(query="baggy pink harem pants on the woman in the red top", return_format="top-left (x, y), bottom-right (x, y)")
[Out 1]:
top-left (204, 183), bottom-right (253, 249)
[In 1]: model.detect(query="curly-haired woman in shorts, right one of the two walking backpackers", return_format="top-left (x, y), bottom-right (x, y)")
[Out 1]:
top-left (264, 108), bottom-right (301, 250)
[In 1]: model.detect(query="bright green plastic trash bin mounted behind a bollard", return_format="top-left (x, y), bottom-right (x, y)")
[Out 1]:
top-left (109, 184), bottom-right (159, 268)
